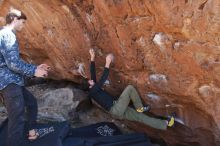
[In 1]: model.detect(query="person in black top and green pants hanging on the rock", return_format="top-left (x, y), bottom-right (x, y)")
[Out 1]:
top-left (81, 49), bottom-right (175, 130)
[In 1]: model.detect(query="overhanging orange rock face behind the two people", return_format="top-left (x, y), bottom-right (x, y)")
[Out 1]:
top-left (0, 0), bottom-right (220, 146)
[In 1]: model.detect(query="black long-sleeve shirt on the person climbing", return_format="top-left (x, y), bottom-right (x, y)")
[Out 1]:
top-left (88, 61), bottom-right (113, 111)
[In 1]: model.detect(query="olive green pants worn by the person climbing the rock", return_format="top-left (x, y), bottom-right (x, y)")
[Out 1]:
top-left (110, 85), bottom-right (167, 130)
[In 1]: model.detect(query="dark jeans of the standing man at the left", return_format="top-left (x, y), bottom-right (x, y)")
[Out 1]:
top-left (1, 84), bottom-right (38, 146)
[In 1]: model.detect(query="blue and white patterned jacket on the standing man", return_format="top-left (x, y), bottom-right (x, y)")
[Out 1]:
top-left (0, 27), bottom-right (36, 90)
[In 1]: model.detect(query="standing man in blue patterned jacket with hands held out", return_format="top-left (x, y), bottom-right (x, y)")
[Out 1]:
top-left (0, 8), bottom-right (50, 146)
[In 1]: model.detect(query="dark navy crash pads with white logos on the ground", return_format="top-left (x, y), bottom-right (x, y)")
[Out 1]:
top-left (0, 120), bottom-right (152, 146)
